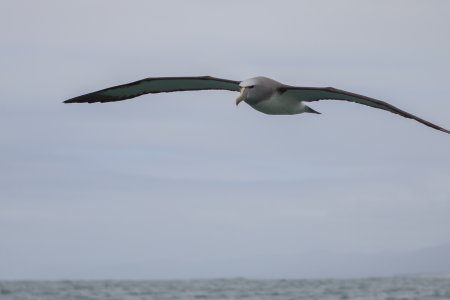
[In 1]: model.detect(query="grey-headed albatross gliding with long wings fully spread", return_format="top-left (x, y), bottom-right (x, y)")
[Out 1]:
top-left (64, 76), bottom-right (450, 134)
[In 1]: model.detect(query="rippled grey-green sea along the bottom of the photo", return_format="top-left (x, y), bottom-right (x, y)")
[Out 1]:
top-left (0, 277), bottom-right (450, 300)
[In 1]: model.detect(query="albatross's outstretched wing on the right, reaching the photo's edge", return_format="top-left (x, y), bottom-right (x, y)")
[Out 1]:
top-left (278, 86), bottom-right (450, 134)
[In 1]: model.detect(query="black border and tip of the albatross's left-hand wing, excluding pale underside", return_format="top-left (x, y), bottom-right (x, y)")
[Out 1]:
top-left (63, 76), bottom-right (240, 104)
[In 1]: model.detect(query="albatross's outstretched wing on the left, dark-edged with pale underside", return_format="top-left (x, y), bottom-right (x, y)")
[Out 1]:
top-left (64, 76), bottom-right (239, 103)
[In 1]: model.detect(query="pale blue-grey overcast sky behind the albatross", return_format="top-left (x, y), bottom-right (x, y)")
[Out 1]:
top-left (0, 1), bottom-right (450, 279)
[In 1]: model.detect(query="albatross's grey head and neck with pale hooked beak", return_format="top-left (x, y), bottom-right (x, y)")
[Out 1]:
top-left (236, 77), bottom-right (281, 106)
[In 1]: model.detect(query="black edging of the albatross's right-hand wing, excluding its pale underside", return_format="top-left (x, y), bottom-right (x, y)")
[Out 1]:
top-left (278, 86), bottom-right (450, 134)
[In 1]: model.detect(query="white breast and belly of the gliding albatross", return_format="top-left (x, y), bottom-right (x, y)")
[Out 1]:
top-left (249, 94), bottom-right (305, 115)
